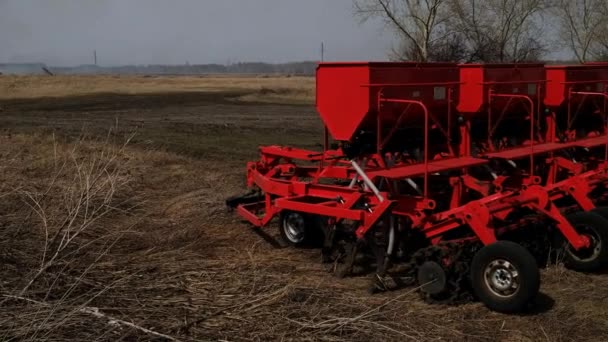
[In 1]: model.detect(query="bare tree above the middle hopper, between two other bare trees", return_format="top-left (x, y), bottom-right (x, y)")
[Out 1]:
top-left (449, 0), bottom-right (550, 62)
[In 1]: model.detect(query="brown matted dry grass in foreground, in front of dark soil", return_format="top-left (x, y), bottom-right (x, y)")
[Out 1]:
top-left (0, 135), bottom-right (608, 341)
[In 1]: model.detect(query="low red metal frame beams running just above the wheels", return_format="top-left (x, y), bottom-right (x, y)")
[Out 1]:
top-left (238, 147), bottom-right (589, 248)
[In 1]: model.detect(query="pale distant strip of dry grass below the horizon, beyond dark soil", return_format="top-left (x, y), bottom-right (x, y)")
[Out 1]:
top-left (0, 75), bottom-right (315, 103)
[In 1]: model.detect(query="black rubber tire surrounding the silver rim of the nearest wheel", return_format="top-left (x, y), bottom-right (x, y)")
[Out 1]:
top-left (471, 241), bottom-right (540, 313)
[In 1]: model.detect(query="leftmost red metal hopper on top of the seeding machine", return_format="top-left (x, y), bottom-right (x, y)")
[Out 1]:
top-left (317, 62), bottom-right (459, 140)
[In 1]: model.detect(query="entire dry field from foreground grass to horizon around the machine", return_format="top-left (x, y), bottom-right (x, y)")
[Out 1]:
top-left (0, 76), bottom-right (608, 341)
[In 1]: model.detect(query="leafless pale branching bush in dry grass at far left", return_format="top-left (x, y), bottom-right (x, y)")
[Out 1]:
top-left (19, 132), bottom-right (134, 296)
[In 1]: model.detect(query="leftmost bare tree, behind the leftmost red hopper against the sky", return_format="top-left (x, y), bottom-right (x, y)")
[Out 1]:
top-left (354, 0), bottom-right (453, 62)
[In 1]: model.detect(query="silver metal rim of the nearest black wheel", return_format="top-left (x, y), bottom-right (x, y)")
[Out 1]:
top-left (484, 259), bottom-right (519, 297)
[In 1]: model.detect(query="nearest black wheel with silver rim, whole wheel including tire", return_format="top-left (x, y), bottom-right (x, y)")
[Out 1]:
top-left (471, 241), bottom-right (540, 313)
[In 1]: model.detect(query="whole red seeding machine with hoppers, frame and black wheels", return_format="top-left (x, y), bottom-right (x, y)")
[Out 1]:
top-left (227, 63), bottom-right (608, 312)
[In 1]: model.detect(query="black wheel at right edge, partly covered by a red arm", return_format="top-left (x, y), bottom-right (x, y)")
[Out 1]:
top-left (564, 211), bottom-right (608, 272)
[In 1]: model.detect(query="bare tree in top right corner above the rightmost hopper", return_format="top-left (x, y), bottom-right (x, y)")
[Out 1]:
top-left (554, 0), bottom-right (608, 62)
